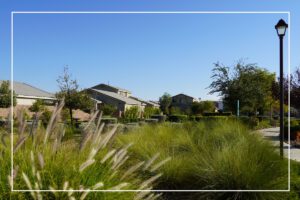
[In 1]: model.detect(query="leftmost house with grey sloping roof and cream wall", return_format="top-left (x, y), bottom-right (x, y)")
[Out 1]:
top-left (0, 80), bottom-right (56, 106)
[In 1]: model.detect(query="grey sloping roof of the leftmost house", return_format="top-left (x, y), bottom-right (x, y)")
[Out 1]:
top-left (0, 80), bottom-right (55, 98)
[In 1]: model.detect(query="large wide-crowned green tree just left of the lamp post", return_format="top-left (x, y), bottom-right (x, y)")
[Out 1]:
top-left (209, 61), bottom-right (275, 114)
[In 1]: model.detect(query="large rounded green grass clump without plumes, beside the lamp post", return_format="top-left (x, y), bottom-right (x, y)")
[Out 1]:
top-left (119, 120), bottom-right (288, 199)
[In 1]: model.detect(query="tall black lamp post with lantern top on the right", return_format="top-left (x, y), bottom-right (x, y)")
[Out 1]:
top-left (275, 19), bottom-right (288, 157)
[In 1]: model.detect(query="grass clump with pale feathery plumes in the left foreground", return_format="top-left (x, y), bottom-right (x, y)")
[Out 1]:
top-left (0, 102), bottom-right (162, 200)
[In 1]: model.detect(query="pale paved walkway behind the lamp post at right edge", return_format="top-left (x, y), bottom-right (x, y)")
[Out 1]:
top-left (259, 127), bottom-right (300, 162)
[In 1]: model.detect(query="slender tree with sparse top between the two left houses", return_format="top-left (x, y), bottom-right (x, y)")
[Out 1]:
top-left (56, 67), bottom-right (93, 125)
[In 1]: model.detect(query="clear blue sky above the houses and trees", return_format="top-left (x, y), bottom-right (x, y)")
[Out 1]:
top-left (0, 0), bottom-right (300, 100)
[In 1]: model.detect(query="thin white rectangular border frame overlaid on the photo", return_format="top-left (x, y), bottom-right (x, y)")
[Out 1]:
top-left (10, 11), bottom-right (291, 192)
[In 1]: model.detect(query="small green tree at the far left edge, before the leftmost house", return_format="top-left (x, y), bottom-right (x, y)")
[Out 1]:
top-left (0, 81), bottom-right (17, 108)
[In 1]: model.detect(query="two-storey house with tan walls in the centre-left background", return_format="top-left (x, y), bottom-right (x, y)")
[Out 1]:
top-left (86, 84), bottom-right (146, 116)
